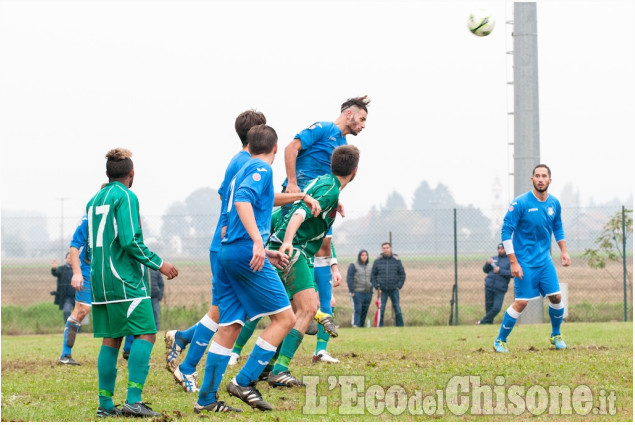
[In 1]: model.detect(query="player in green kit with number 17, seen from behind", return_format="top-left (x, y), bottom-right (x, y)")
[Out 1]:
top-left (86, 148), bottom-right (178, 417)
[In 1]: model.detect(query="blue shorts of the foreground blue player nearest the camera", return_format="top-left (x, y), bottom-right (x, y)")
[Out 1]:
top-left (214, 242), bottom-right (291, 326)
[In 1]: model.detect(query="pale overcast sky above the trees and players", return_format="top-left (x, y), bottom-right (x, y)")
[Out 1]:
top-left (0, 0), bottom-right (635, 232)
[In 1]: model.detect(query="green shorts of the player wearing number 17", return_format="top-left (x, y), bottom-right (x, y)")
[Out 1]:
top-left (92, 298), bottom-right (157, 338)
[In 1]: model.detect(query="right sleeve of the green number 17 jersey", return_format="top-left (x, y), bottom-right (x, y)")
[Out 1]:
top-left (115, 192), bottom-right (163, 270)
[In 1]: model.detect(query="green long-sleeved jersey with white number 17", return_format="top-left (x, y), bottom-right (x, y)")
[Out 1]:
top-left (86, 182), bottom-right (163, 304)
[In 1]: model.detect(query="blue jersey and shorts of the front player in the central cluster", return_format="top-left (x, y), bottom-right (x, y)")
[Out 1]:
top-left (213, 158), bottom-right (291, 326)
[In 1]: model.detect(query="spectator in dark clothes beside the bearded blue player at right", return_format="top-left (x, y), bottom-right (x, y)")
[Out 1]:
top-left (476, 243), bottom-right (512, 325)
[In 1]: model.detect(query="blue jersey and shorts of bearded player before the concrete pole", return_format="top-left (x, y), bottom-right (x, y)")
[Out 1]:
top-left (501, 191), bottom-right (564, 300)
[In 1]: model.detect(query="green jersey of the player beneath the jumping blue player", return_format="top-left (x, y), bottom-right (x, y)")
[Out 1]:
top-left (271, 174), bottom-right (341, 258)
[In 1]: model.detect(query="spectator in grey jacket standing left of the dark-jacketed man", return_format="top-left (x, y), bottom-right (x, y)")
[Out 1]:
top-left (346, 249), bottom-right (373, 328)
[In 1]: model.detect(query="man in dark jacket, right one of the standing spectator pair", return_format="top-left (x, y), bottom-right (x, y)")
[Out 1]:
top-left (370, 242), bottom-right (406, 326)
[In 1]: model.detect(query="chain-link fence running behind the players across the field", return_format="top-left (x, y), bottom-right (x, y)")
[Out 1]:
top-left (1, 206), bottom-right (633, 328)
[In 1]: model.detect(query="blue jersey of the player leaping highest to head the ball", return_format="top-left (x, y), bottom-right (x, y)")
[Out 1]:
top-left (282, 121), bottom-right (346, 189)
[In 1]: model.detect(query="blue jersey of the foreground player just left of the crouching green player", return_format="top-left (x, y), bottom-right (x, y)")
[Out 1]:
top-left (222, 158), bottom-right (274, 244)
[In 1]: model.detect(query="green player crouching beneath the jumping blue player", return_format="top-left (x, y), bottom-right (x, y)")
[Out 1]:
top-left (268, 145), bottom-right (359, 386)
